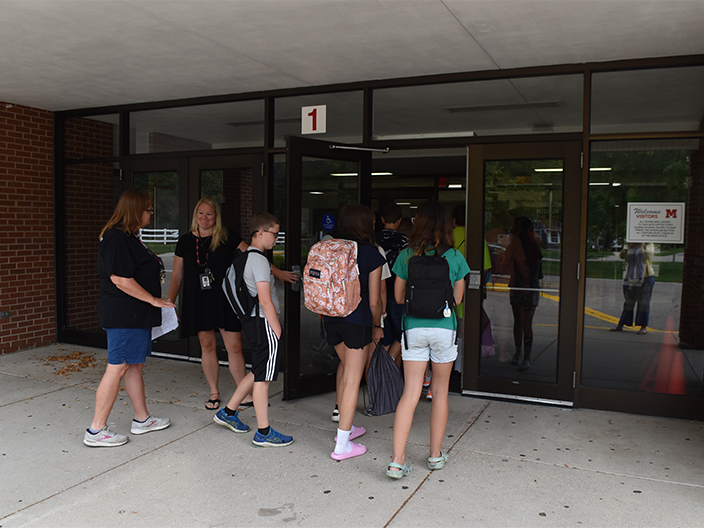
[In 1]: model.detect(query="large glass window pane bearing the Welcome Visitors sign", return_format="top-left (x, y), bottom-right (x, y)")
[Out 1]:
top-left (582, 140), bottom-right (704, 395)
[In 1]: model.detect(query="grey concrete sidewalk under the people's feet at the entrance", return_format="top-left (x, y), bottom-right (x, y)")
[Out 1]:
top-left (0, 345), bottom-right (704, 528)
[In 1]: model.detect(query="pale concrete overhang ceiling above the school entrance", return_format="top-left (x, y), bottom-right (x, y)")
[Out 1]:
top-left (0, 0), bottom-right (704, 110)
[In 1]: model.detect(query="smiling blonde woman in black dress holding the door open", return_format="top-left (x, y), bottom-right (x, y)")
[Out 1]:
top-left (169, 196), bottom-right (298, 411)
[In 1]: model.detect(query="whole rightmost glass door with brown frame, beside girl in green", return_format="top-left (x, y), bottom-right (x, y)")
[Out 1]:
top-left (463, 143), bottom-right (581, 405)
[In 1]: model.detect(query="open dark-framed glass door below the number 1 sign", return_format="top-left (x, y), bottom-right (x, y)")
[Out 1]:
top-left (284, 137), bottom-right (371, 400)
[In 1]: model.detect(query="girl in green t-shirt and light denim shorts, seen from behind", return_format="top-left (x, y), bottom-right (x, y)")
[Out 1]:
top-left (386, 200), bottom-right (469, 479)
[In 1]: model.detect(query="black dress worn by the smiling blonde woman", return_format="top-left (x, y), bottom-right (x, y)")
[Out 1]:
top-left (175, 232), bottom-right (242, 338)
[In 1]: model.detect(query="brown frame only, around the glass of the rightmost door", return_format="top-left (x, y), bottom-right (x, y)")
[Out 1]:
top-left (462, 141), bottom-right (585, 405)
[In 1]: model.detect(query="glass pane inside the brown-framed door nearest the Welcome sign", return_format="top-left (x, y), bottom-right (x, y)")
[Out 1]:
top-left (480, 159), bottom-right (564, 383)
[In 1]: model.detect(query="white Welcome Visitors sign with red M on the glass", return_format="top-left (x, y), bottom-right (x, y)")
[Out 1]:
top-left (626, 202), bottom-right (684, 244)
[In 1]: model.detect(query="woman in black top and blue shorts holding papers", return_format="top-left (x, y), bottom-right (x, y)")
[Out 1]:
top-left (83, 191), bottom-right (174, 447)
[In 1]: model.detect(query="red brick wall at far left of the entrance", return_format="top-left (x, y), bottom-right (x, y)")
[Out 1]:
top-left (0, 102), bottom-right (56, 354)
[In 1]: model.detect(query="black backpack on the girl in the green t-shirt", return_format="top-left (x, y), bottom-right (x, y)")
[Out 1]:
top-left (404, 248), bottom-right (455, 319)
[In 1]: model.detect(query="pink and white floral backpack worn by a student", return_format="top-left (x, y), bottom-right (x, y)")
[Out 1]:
top-left (303, 239), bottom-right (362, 317)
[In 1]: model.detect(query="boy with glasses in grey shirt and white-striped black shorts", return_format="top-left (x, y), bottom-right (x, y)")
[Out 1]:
top-left (213, 213), bottom-right (293, 447)
